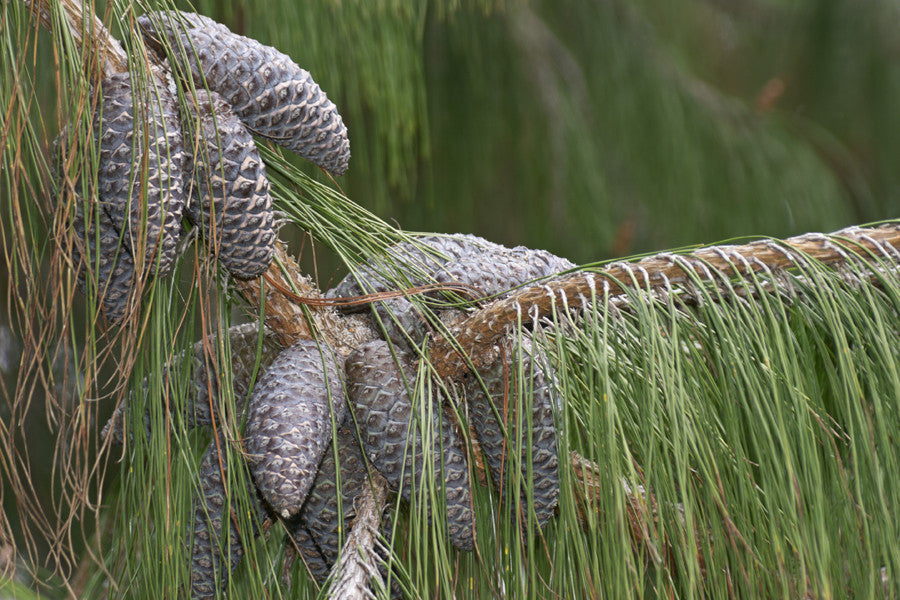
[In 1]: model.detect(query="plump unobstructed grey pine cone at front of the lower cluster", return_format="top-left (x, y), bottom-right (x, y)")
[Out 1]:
top-left (244, 340), bottom-right (346, 519)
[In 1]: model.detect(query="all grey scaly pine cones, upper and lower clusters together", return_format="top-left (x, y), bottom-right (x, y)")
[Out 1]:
top-left (64, 5), bottom-right (573, 598)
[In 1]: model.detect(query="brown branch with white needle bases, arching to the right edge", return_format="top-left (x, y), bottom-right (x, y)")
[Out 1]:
top-left (431, 223), bottom-right (900, 378)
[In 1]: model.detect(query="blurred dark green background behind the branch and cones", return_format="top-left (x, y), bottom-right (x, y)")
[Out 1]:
top-left (0, 0), bottom-right (900, 584)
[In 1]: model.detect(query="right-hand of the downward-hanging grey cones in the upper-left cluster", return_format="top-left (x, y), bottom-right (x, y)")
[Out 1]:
top-left (185, 90), bottom-right (275, 279)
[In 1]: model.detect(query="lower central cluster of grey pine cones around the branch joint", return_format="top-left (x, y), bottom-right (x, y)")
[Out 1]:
top-left (104, 235), bottom-right (573, 598)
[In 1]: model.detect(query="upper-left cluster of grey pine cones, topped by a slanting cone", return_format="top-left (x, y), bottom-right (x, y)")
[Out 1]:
top-left (57, 11), bottom-right (350, 321)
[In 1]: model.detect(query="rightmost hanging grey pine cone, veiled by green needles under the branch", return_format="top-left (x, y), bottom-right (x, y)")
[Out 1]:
top-left (466, 339), bottom-right (559, 527)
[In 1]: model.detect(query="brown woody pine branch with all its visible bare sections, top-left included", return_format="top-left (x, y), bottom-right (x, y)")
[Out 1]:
top-left (23, 0), bottom-right (900, 598)
